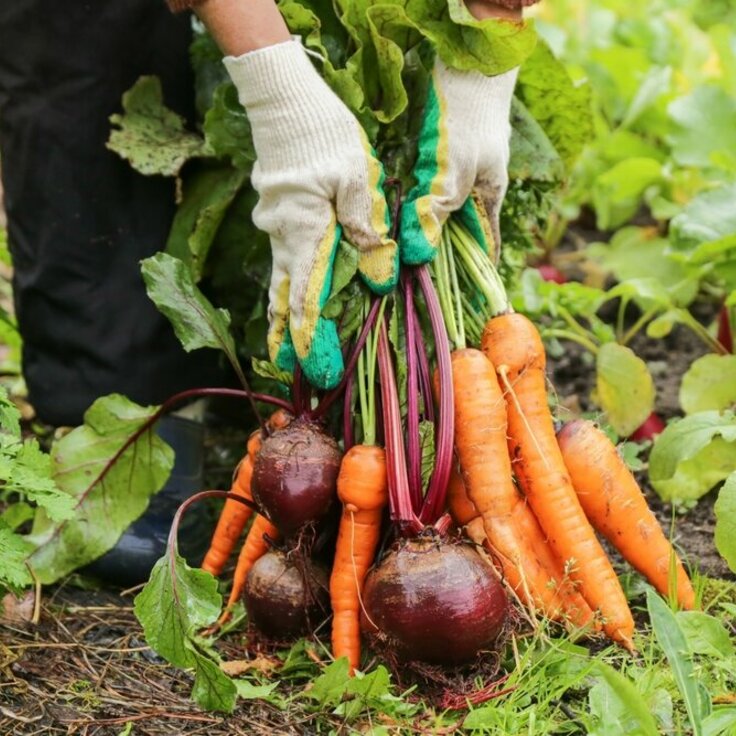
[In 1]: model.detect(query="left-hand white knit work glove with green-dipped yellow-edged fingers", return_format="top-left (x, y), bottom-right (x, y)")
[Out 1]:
top-left (224, 40), bottom-right (398, 388)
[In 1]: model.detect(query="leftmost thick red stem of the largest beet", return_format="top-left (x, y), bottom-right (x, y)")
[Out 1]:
top-left (378, 320), bottom-right (423, 536)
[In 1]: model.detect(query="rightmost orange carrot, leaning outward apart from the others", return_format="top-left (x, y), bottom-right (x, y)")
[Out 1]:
top-left (557, 419), bottom-right (695, 609)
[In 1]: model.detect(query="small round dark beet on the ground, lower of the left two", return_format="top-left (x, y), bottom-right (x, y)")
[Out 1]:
top-left (243, 550), bottom-right (330, 640)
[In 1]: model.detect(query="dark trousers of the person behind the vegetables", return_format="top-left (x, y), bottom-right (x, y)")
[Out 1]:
top-left (0, 0), bottom-right (218, 424)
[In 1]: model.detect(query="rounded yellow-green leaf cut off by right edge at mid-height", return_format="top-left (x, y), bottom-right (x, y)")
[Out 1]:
top-left (680, 355), bottom-right (736, 414)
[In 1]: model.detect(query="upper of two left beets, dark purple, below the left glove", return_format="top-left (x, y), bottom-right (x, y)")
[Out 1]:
top-left (252, 420), bottom-right (342, 538)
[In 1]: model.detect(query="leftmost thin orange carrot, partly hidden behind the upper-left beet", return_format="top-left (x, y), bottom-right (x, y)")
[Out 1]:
top-left (202, 409), bottom-right (292, 575)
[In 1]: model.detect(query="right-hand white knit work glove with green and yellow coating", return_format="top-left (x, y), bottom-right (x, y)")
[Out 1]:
top-left (400, 58), bottom-right (518, 264)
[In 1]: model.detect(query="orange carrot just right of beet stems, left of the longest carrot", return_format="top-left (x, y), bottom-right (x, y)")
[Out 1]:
top-left (452, 348), bottom-right (588, 618)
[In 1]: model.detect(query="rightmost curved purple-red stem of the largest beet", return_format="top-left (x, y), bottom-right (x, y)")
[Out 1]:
top-left (417, 266), bottom-right (455, 524)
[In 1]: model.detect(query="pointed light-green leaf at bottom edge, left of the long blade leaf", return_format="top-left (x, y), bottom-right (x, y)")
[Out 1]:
top-left (588, 661), bottom-right (659, 736)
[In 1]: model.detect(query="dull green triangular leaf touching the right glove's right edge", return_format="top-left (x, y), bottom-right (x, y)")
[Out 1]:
top-left (509, 97), bottom-right (565, 183)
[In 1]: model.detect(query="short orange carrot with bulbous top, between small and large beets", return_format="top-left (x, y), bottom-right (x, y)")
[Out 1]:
top-left (330, 445), bottom-right (388, 674)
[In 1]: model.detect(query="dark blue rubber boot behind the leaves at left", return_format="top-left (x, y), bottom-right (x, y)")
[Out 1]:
top-left (81, 416), bottom-right (213, 587)
